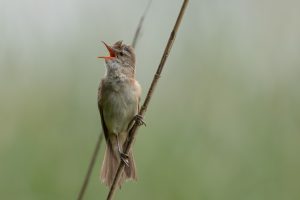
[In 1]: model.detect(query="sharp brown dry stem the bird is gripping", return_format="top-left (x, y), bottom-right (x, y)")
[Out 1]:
top-left (107, 0), bottom-right (188, 200)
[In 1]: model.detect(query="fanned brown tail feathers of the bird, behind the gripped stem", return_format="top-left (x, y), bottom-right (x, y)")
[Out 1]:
top-left (100, 146), bottom-right (137, 188)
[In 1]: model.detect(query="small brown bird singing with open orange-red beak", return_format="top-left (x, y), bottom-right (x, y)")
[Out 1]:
top-left (98, 41), bottom-right (141, 187)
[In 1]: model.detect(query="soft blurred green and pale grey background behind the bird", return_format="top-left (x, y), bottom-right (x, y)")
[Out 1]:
top-left (0, 0), bottom-right (300, 200)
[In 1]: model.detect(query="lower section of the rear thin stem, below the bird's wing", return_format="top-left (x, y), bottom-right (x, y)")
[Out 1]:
top-left (77, 133), bottom-right (103, 200)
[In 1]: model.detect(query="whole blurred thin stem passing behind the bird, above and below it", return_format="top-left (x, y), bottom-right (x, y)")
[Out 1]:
top-left (77, 0), bottom-right (152, 200)
